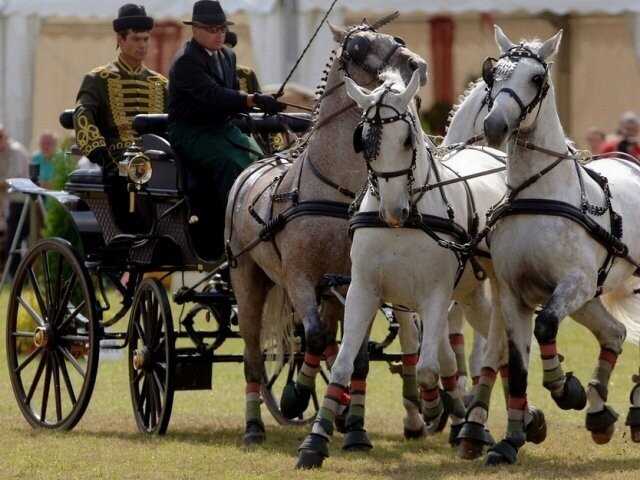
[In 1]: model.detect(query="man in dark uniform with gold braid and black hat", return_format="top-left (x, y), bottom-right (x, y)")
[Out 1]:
top-left (73, 3), bottom-right (168, 176)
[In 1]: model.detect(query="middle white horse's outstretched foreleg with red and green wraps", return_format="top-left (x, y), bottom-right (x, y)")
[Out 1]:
top-left (296, 277), bottom-right (380, 469)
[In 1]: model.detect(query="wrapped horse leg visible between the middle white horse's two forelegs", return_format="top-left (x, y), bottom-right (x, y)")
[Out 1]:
top-left (395, 310), bottom-right (425, 439)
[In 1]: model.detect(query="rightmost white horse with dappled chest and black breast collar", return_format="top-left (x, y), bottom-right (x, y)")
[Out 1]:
top-left (478, 26), bottom-right (640, 465)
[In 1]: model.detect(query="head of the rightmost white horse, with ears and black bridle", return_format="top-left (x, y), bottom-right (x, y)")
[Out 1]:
top-left (482, 25), bottom-right (562, 147)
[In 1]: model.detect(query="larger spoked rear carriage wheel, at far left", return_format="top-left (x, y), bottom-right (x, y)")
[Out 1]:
top-left (6, 238), bottom-right (99, 430)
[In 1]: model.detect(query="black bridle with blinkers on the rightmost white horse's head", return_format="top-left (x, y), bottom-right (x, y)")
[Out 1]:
top-left (482, 43), bottom-right (549, 125)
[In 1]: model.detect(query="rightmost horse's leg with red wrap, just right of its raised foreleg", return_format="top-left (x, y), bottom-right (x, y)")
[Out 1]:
top-left (572, 298), bottom-right (626, 444)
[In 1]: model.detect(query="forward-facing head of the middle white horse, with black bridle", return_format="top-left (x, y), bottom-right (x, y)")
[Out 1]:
top-left (345, 70), bottom-right (425, 227)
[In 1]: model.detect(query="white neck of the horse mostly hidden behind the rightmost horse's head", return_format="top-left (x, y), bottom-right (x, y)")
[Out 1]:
top-left (442, 81), bottom-right (486, 145)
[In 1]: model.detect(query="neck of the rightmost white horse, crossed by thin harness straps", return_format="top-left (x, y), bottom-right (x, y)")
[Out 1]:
top-left (507, 87), bottom-right (577, 198)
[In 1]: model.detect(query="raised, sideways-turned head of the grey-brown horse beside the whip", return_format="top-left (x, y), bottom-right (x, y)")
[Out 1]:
top-left (329, 17), bottom-right (427, 88)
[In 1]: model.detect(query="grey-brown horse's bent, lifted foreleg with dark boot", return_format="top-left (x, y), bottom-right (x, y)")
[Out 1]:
top-left (280, 281), bottom-right (335, 418)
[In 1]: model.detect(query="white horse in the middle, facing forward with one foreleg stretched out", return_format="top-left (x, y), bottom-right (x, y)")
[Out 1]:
top-left (297, 71), bottom-right (504, 468)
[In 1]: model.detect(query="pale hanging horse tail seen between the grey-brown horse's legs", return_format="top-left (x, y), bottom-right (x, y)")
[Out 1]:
top-left (260, 285), bottom-right (296, 377)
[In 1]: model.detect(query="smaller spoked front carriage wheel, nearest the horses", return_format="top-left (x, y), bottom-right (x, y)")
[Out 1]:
top-left (129, 278), bottom-right (175, 435)
